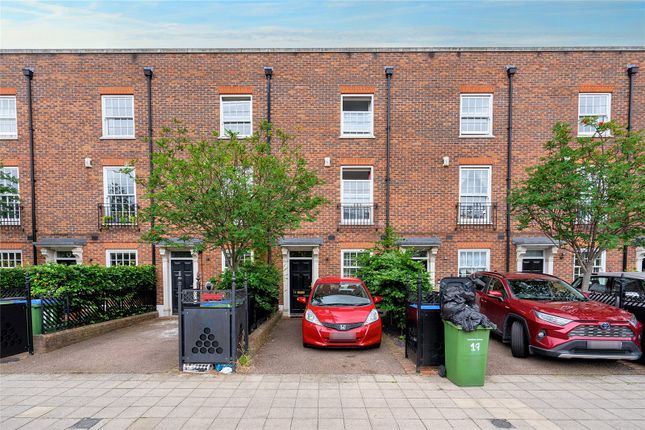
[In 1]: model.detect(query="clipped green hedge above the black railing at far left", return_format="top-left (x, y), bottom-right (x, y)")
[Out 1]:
top-left (0, 264), bottom-right (156, 297)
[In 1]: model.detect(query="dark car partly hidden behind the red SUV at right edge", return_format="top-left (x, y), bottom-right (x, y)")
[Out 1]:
top-left (572, 272), bottom-right (645, 340)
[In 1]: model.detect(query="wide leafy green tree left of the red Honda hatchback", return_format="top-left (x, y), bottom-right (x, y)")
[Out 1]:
top-left (139, 121), bottom-right (325, 271)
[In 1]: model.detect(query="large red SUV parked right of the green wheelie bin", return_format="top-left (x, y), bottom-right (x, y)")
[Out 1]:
top-left (473, 272), bottom-right (643, 360)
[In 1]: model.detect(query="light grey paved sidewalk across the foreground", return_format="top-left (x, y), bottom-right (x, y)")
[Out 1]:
top-left (0, 374), bottom-right (645, 430)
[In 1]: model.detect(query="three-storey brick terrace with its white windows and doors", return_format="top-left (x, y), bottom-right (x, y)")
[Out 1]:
top-left (0, 47), bottom-right (645, 315)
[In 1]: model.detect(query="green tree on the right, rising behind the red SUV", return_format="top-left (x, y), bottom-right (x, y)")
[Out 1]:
top-left (510, 117), bottom-right (645, 291)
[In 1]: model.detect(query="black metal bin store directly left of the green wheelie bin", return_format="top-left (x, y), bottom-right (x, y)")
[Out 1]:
top-left (405, 291), bottom-right (444, 371)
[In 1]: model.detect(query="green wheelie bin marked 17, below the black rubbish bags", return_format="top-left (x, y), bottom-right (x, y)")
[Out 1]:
top-left (443, 320), bottom-right (491, 387)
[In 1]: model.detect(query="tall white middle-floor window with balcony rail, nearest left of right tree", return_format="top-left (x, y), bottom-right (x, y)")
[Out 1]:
top-left (459, 166), bottom-right (492, 224)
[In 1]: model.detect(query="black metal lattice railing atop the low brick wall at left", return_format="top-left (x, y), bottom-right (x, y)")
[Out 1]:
top-left (42, 290), bottom-right (156, 333)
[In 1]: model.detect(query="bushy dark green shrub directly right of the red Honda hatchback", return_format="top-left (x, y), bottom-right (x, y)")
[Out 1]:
top-left (356, 227), bottom-right (430, 332)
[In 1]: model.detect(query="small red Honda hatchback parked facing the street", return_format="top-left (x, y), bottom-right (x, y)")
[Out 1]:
top-left (297, 278), bottom-right (382, 348)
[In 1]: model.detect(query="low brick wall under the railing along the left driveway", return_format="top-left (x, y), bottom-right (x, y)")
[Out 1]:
top-left (34, 311), bottom-right (159, 353)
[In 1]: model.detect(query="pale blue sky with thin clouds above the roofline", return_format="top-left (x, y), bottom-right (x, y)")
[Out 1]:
top-left (0, 0), bottom-right (645, 49)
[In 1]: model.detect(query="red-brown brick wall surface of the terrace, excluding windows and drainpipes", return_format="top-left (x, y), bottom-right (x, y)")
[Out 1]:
top-left (0, 49), bottom-right (645, 314)
